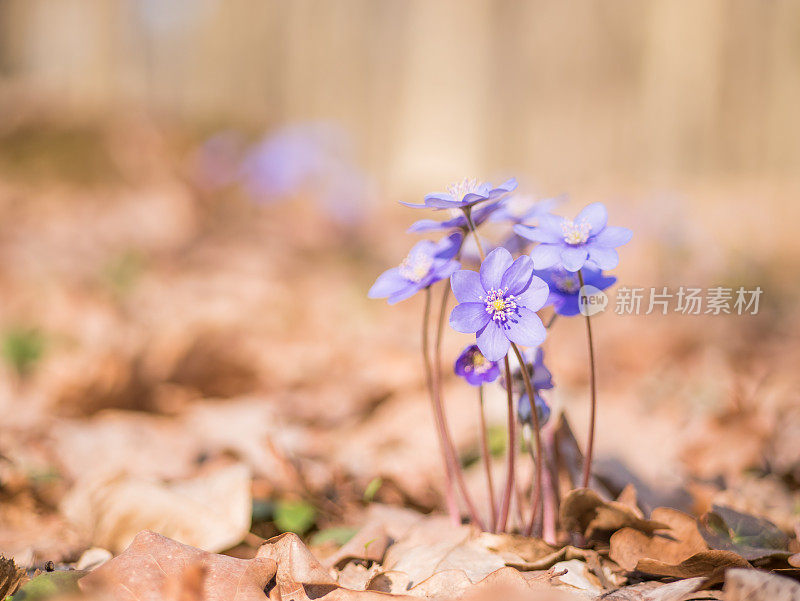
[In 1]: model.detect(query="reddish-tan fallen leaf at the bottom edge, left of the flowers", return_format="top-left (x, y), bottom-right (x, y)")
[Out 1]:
top-left (79, 531), bottom-right (277, 601)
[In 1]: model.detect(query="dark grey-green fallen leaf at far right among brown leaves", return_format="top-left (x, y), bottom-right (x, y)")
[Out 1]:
top-left (700, 505), bottom-right (792, 561)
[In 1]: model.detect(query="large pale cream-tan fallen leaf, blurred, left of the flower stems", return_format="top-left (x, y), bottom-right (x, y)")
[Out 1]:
top-left (61, 465), bottom-right (252, 552)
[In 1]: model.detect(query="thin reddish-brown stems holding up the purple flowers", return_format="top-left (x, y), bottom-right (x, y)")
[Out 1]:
top-left (422, 207), bottom-right (597, 536)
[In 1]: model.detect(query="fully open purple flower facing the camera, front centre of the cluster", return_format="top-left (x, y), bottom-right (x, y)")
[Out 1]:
top-left (450, 248), bottom-right (548, 361)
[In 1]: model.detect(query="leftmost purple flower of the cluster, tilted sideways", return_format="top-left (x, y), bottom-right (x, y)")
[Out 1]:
top-left (367, 233), bottom-right (464, 305)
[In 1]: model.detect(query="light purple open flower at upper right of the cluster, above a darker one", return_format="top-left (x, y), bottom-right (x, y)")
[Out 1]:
top-left (514, 202), bottom-right (633, 271)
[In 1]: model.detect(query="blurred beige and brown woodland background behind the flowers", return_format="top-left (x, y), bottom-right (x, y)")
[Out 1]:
top-left (0, 0), bottom-right (800, 564)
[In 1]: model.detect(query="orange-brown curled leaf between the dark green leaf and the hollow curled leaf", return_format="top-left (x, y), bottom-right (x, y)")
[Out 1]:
top-left (609, 507), bottom-right (708, 572)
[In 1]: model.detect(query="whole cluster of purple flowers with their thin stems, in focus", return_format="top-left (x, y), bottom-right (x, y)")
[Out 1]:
top-left (369, 178), bottom-right (632, 533)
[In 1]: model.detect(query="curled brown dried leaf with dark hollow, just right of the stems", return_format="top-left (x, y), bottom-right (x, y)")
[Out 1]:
top-left (561, 488), bottom-right (668, 538)
